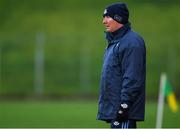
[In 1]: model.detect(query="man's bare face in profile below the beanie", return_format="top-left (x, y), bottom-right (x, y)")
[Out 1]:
top-left (103, 16), bottom-right (123, 32)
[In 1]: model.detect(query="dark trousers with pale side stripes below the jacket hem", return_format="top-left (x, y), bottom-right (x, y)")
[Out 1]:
top-left (111, 120), bottom-right (136, 129)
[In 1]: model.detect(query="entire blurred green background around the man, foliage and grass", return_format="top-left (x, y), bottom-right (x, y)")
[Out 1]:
top-left (0, 0), bottom-right (180, 128)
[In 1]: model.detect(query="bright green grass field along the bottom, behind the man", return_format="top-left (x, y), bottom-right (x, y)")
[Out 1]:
top-left (0, 101), bottom-right (180, 128)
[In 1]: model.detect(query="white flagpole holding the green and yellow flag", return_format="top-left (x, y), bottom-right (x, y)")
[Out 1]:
top-left (156, 73), bottom-right (166, 129)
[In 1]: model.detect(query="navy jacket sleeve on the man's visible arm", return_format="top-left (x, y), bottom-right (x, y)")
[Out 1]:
top-left (121, 42), bottom-right (145, 105)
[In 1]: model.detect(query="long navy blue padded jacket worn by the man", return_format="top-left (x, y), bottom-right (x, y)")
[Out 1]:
top-left (97, 24), bottom-right (146, 121)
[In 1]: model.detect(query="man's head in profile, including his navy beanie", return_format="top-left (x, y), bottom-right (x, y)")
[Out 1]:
top-left (103, 3), bottom-right (129, 32)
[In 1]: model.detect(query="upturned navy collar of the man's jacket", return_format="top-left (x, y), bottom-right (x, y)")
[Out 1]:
top-left (105, 23), bottom-right (131, 44)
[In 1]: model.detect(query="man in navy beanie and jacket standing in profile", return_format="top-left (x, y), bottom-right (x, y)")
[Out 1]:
top-left (97, 3), bottom-right (146, 128)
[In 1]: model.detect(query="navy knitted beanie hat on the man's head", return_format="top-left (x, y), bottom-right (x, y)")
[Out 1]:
top-left (103, 2), bottom-right (129, 24)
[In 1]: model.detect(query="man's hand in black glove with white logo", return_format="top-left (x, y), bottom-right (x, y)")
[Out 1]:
top-left (117, 103), bottom-right (129, 121)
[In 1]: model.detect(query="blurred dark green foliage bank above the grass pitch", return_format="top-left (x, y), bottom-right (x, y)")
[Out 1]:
top-left (0, 0), bottom-right (180, 98)
